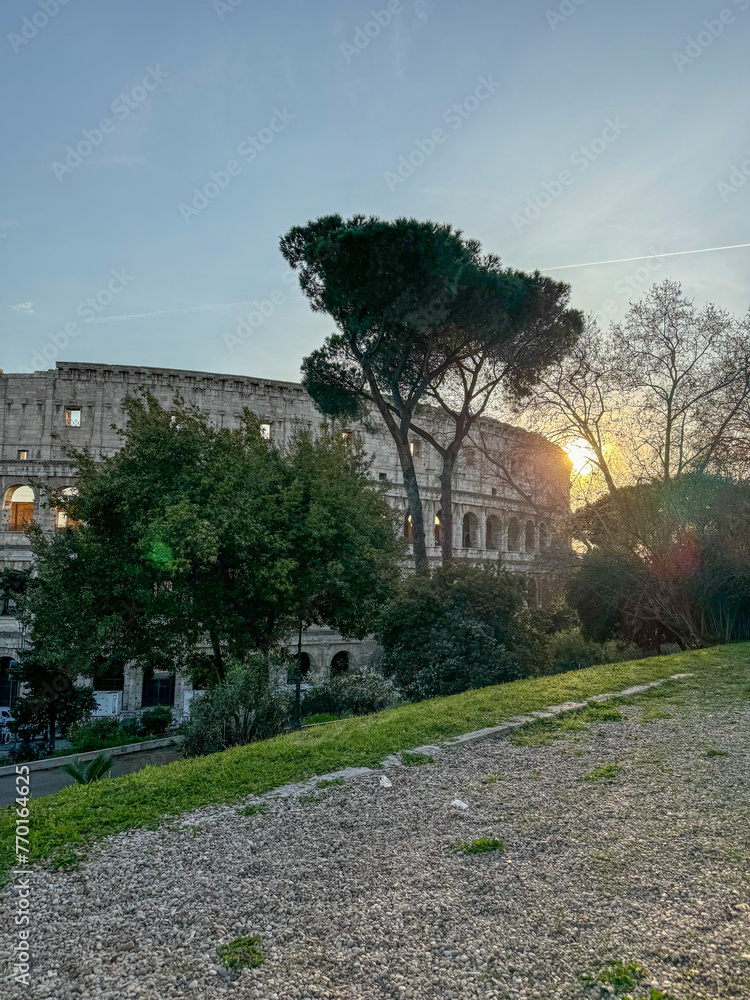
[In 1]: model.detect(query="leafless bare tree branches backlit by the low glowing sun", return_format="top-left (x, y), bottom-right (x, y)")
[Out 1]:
top-left (521, 281), bottom-right (750, 502)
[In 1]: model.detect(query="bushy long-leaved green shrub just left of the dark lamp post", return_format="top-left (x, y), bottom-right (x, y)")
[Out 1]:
top-left (183, 657), bottom-right (292, 757)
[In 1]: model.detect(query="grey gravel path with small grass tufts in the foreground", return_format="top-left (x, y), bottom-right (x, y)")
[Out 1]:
top-left (0, 676), bottom-right (750, 1000)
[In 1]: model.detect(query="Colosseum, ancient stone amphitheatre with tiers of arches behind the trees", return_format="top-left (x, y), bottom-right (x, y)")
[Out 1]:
top-left (0, 362), bottom-right (570, 718)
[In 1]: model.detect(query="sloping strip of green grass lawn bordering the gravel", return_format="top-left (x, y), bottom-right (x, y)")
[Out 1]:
top-left (0, 643), bottom-right (750, 876)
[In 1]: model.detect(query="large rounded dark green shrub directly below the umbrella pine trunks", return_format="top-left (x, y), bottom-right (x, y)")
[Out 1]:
top-left (377, 564), bottom-right (545, 700)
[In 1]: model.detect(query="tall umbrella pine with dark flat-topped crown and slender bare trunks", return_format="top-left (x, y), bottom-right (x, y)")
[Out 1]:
top-left (281, 216), bottom-right (582, 572)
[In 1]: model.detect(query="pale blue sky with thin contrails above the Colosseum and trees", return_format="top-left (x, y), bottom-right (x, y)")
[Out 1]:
top-left (0, 0), bottom-right (750, 380)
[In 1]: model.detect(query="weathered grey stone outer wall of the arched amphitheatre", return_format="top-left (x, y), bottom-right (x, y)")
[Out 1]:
top-left (0, 362), bottom-right (569, 713)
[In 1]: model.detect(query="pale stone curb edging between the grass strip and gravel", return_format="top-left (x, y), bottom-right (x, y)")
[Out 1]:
top-left (178, 673), bottom-right (692, 826)
